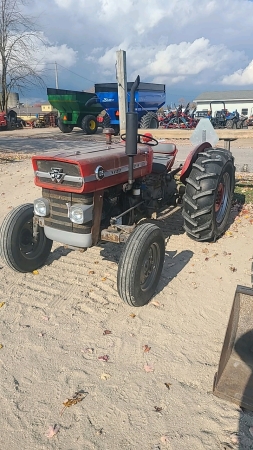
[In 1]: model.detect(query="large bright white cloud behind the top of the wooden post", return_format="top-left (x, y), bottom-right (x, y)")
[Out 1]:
top-left (98, 37), bottom-right (243, 83)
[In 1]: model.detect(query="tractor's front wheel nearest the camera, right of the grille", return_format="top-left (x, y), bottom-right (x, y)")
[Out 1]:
top-left (117, 223), bottom-right (165, 306)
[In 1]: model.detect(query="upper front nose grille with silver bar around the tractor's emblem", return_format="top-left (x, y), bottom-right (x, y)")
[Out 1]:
top-left (36, 159), bottom-right (83, 188)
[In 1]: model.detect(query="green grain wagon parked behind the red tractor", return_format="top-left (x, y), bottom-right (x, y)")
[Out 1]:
top-left (47, 88), bottom-right (103, 134)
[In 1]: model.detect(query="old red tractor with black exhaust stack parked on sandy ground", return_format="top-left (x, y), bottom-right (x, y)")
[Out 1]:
top-left (0, 77), bottom-right (235, 306)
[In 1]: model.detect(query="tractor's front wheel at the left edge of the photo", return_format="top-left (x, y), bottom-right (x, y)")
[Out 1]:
top-left (0, 203), bottom-right (53, 272)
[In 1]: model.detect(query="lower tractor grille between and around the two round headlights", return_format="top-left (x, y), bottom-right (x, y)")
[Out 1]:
top-left (42, 189), bottom-right (93, 234)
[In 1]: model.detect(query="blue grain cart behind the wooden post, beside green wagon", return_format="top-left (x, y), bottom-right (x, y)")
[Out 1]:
top-left (95, 82), bottom-right (166, 134)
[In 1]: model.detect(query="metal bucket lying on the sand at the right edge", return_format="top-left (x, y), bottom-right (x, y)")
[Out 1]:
top-left (213, 286), bottom-right (253, 411)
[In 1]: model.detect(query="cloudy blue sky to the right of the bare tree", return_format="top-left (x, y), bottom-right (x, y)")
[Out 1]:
top-left (20, 0), bottom-right (253, 103)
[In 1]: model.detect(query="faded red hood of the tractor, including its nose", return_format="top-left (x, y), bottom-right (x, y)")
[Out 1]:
top-left (32, 142), bottom-right (153, 193)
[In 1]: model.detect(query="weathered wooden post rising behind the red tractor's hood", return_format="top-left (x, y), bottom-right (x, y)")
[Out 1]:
top-left (116, 50), bottom-right (127, 134)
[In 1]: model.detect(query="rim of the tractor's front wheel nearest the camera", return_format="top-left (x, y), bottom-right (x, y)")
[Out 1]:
top-left (140, 243), bottom-right (161, 291)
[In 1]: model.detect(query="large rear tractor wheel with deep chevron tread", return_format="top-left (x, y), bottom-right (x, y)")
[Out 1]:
top-left (182, 149), bottom-right (235, 241)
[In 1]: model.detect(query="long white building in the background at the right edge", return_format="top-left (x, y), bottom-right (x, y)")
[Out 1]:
top-left (193, 90), bottom-right (253, 117)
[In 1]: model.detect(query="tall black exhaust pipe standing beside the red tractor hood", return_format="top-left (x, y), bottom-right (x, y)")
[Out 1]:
top-left (126, 75), bottom-right (140, 189)
